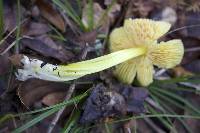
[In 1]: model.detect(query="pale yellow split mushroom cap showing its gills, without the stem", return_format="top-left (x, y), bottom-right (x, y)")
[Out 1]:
top-left (110, 19), bottom-right (184, 86)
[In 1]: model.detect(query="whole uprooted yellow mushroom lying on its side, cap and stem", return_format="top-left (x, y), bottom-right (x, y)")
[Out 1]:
top-left (16, 19), bottom-right (184, 86)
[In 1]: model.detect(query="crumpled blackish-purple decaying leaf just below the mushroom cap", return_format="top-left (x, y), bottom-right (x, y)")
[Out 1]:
top-left (80, 84), bottom-right (147, 123)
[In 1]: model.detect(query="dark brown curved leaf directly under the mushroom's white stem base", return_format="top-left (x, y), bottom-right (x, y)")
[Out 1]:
top-left (17, 79), bottom-right (69, 107)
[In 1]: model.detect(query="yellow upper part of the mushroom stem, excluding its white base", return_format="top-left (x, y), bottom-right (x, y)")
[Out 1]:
top-left (55, 48), bottom-right (146, 77)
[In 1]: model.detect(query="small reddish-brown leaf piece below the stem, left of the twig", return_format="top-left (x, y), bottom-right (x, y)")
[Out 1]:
top-left (42, 92), bottom-right (66, 106)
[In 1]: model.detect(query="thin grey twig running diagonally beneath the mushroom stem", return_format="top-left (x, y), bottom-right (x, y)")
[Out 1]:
top-left (47, 46), bottom-right (88, 133)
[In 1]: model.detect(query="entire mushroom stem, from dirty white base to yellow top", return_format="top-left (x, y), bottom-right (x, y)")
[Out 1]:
top-left (16, 47), bottom-right (146, 81)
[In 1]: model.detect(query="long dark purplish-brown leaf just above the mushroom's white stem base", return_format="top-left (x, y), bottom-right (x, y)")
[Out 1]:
top-left (20, 35), bottom-right (74, 63)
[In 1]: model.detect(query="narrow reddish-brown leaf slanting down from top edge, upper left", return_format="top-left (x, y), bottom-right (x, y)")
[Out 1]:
top-left (35, 0), bottom-right (65, 32)
